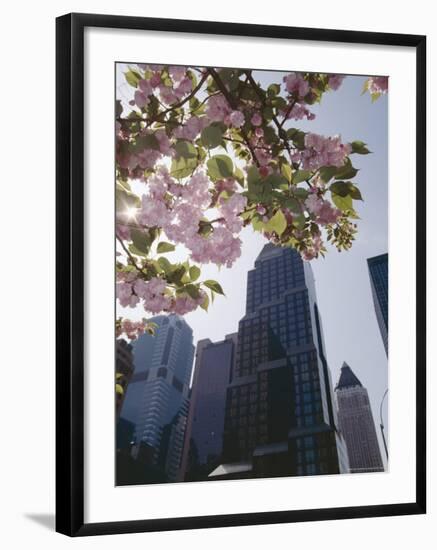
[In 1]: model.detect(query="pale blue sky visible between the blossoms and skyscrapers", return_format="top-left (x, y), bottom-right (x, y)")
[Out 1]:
top-left (117, 65), bottom-right (388, 459)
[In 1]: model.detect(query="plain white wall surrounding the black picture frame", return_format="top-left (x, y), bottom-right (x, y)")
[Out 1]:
top-left (0, 0), bottom-right (430, 550)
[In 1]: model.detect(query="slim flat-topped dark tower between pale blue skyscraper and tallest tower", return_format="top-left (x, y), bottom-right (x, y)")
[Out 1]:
top-left (181, 334), bottom-right (237, 481)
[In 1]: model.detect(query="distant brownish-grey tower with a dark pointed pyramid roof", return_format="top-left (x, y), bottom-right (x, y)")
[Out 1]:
top-left (335, 363), bottom-right (384, 473)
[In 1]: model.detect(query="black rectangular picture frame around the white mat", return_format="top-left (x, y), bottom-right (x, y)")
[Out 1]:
top-left (56, 13), bottom-right (426, 536)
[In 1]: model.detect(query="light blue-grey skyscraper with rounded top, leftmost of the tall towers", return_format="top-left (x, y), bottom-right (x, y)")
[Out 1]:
top-left (120, 315), bottom-right (194, 481)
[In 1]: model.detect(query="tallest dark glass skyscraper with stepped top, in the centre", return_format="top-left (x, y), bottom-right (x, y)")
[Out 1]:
top-left (210, 244), bottom-right (348, 479)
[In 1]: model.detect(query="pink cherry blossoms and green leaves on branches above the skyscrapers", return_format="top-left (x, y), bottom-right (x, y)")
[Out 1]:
top-left (116, 64), bottom-right (378, 332)
